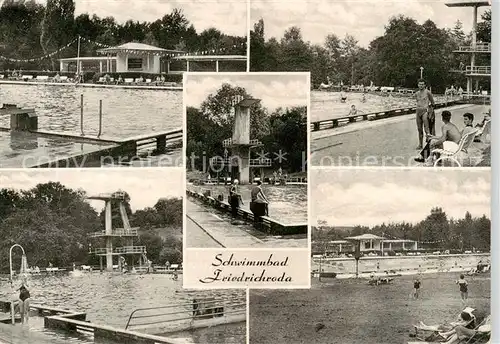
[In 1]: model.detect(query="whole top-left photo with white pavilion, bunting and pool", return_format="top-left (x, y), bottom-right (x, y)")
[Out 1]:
top-left (0, 0), bottom-right (248, 168)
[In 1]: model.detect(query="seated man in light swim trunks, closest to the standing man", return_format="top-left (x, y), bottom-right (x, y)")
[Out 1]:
top-left (415, 110), bottom-right (462, 162)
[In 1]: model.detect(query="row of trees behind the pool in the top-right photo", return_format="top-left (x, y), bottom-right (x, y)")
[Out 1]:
top-left (250, 10), bottom-right (491, 93)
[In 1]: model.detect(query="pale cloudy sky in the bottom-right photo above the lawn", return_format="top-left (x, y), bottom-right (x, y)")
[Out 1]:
top-left (310, 169), bottom-right (491, 226)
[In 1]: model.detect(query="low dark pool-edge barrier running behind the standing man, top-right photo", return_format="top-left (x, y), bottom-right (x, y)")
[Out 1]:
top-left (311, 100), bottom-right (464, 131)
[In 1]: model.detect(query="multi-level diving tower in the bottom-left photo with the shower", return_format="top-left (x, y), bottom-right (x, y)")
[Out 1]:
top-left (87, 191), bottom-right (146, 271)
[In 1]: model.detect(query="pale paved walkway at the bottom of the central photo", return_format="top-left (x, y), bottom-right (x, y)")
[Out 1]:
top-left (186, 199), bottom-right (307, 248)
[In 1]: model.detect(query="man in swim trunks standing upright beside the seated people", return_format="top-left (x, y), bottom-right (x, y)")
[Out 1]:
top-left (415, 79), bottom-right (436, 149)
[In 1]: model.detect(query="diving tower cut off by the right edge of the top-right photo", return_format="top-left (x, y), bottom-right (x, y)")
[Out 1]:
top-left (446, 0), bottom-right (491, 94)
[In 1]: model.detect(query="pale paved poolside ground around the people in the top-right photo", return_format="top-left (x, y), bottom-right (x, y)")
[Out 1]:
top-left (311, 105), bottom-right (490, 167)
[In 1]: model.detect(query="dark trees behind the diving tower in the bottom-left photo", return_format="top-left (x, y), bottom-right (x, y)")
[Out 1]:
top-left (0, 182), bottom-right (182, 273)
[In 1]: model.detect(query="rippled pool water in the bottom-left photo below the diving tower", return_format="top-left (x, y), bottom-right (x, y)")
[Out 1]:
top-left (0, 272), bottom-right (246, 344)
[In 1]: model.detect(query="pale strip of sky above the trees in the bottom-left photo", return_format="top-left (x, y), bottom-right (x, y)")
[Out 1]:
top-left (0, 168), bottom-right (184, 211)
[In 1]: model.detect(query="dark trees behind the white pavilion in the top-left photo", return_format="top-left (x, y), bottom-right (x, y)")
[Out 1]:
top-left (0, 0), bottom-right (246, 70)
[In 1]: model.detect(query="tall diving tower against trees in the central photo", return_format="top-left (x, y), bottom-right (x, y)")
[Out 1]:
top-left (210, 96), bottom-right (271, 184)
